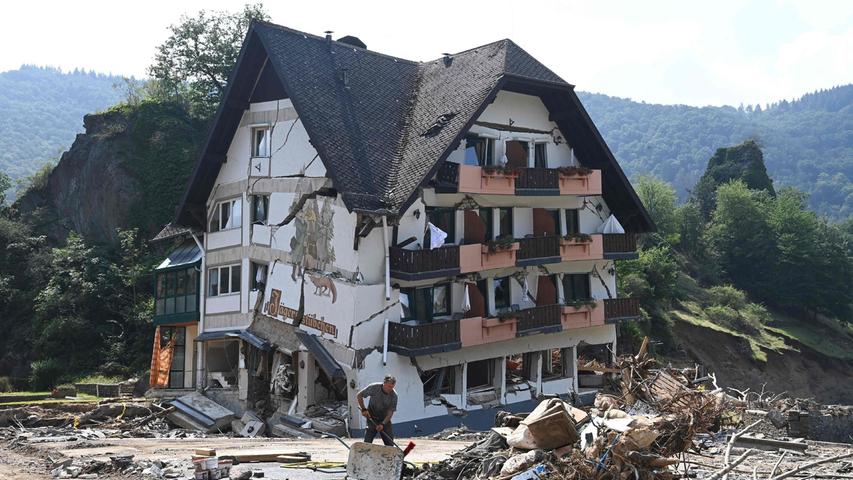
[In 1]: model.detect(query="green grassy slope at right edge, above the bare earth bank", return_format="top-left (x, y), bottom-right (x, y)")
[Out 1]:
top-left (767, 314), bottom-right (853, 360)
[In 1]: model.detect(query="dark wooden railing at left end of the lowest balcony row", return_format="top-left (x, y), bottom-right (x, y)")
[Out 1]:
top-left (388, 320), bottom-right (461, 356)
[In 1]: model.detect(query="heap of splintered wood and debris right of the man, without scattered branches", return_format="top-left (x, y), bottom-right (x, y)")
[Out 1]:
top-left (417, 336), bottom-right (732, 480)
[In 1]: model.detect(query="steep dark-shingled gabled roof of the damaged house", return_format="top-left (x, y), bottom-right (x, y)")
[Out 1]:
top-left (177, 22), bottom-right (651, 231)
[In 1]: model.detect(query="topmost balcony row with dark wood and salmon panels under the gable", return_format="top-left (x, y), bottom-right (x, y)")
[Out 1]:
top-left (436, 162), bottom-right (601, 195)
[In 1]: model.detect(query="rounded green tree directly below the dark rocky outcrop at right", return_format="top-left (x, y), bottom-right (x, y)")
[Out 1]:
top-left (706, 180), bottom-right (779, 299)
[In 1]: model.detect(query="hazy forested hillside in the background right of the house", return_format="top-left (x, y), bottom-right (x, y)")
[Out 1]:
top-left (579, 85), bottom-right (853, 220)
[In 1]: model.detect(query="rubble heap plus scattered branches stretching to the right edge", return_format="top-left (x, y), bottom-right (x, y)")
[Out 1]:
top-left (416, 342), bottom-right (853, 480)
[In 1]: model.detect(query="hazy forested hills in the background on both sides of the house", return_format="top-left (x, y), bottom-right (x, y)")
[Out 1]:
top-left (0, 66), bottom-right (853, 220)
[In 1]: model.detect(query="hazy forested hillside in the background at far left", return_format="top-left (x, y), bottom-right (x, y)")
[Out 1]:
top-left (0, 65), bottom-right (122, 186)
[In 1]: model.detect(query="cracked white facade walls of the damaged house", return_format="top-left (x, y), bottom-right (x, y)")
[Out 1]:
top-left (197, 88), bottom-right (632, 429)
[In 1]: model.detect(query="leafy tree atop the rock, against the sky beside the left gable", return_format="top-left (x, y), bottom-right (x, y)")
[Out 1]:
top-left (148, 3), bottom-right (269, 118)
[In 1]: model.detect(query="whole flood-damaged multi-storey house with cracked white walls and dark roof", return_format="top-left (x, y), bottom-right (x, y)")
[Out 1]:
top-left (152, 22), bottom-right (653, 436)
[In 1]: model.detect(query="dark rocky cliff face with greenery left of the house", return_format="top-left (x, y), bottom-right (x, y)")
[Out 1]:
top-left (15, 103), bottom-right (205, 244)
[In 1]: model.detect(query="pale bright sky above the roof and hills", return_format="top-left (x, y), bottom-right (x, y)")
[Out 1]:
top-left (0, 0), bottom-right (853, 106)
